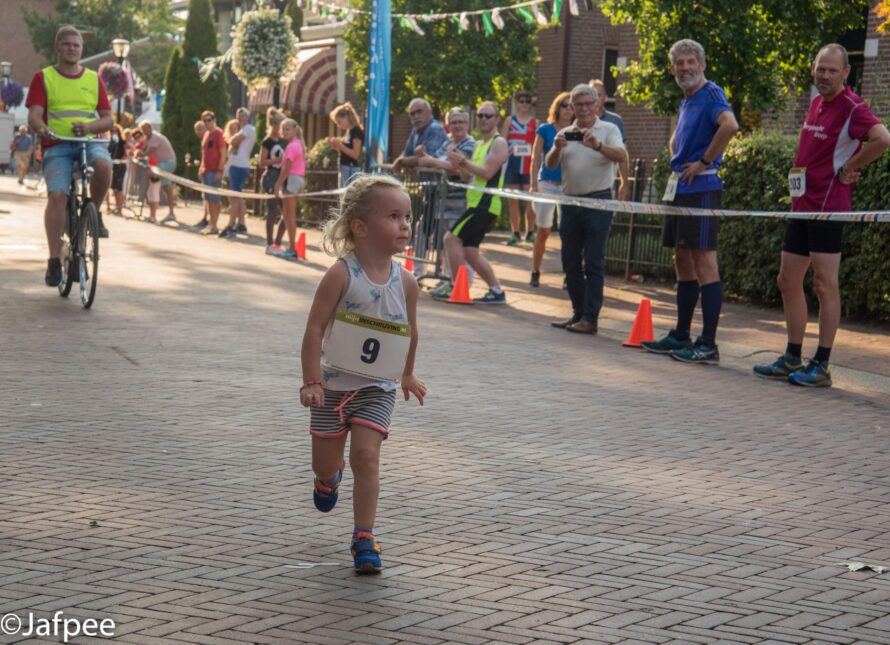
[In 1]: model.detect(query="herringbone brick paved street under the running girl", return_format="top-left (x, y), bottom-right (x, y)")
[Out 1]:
top-left (0, 177), bottom-right (890, 645)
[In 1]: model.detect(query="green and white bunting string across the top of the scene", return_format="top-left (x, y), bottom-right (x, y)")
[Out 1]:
top-left (297, 0), bottom-right (594, 36)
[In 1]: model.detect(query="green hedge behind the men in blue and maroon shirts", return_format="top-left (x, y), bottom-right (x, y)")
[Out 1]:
top-left (655, 130), bottom-right (890, 322)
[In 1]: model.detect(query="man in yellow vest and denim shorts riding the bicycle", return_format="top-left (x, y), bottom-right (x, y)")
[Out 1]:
top-left (25, 25), bottom-right (114, 287)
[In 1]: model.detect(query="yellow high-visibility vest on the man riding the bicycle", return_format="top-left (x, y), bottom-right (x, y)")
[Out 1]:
top-left (43, 66), bottom-right (99, 138)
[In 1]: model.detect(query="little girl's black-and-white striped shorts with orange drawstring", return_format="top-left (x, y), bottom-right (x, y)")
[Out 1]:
top-left (309, 387), bottom-right (396, 438)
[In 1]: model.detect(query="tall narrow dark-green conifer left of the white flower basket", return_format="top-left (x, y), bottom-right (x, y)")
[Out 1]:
top-left (161, 0), bottom-right (229, 172)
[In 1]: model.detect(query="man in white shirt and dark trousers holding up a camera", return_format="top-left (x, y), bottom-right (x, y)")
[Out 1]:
top-left (544, 84), bottom-right (627, 334)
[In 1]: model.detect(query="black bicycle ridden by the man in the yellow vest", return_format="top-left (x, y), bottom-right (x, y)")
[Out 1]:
top-left (50, 134), bottom-right (110, 309)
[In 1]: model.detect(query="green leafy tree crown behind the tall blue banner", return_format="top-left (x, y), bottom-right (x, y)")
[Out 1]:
top-left (345, 0), bottom-right (539, 112)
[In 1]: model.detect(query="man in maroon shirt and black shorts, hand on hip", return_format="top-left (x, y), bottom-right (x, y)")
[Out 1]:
top-left (754, 45), bottom-right (890, 387)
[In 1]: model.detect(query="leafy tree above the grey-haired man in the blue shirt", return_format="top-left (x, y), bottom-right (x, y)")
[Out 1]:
top-left (600, 0), bottom-right (870, 114)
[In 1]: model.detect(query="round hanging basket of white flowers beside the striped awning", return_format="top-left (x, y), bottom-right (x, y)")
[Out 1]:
top-left (232, 9), bottom-right (297, 89)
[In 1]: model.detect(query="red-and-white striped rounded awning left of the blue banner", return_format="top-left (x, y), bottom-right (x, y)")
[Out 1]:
top-left (248, 45), bottom-right (337, 114)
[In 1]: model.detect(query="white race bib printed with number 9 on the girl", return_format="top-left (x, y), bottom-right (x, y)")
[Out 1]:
top-left (324, 309), bottom-right (411, 381)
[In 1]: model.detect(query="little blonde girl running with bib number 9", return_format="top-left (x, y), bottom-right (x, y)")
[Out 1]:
top-left (300, 175), bottom-right (426, 573)
